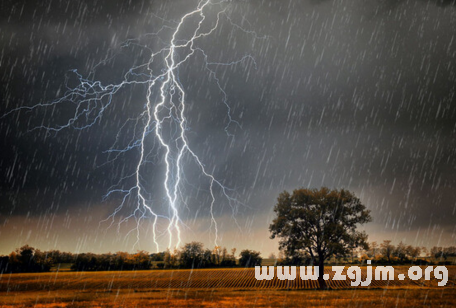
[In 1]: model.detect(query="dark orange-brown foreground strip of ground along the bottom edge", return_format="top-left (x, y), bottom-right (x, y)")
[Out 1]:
top-left (0, 289), bottom-right (456, 308)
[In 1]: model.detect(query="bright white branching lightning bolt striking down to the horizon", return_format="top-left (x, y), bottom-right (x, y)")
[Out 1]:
top-left (0, 0), bottom-right (266, 252)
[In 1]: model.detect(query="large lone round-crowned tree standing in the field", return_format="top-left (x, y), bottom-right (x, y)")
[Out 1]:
top-left (269, 187), bottom-right (372, 289)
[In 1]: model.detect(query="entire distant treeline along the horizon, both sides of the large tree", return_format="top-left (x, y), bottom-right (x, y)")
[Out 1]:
top-left (0, 240), bottom-right (456, 274)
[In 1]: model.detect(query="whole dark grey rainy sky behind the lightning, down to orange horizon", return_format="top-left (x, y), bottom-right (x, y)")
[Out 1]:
top-left (0, 0), bottom-right (456, 257)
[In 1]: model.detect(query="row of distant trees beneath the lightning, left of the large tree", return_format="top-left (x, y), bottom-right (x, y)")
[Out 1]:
top-left (0, 242), bottom-right (262, 273)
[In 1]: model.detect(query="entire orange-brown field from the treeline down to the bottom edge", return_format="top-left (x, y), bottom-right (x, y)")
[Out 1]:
top-left (0, 266), bottom-right (456, 307)
